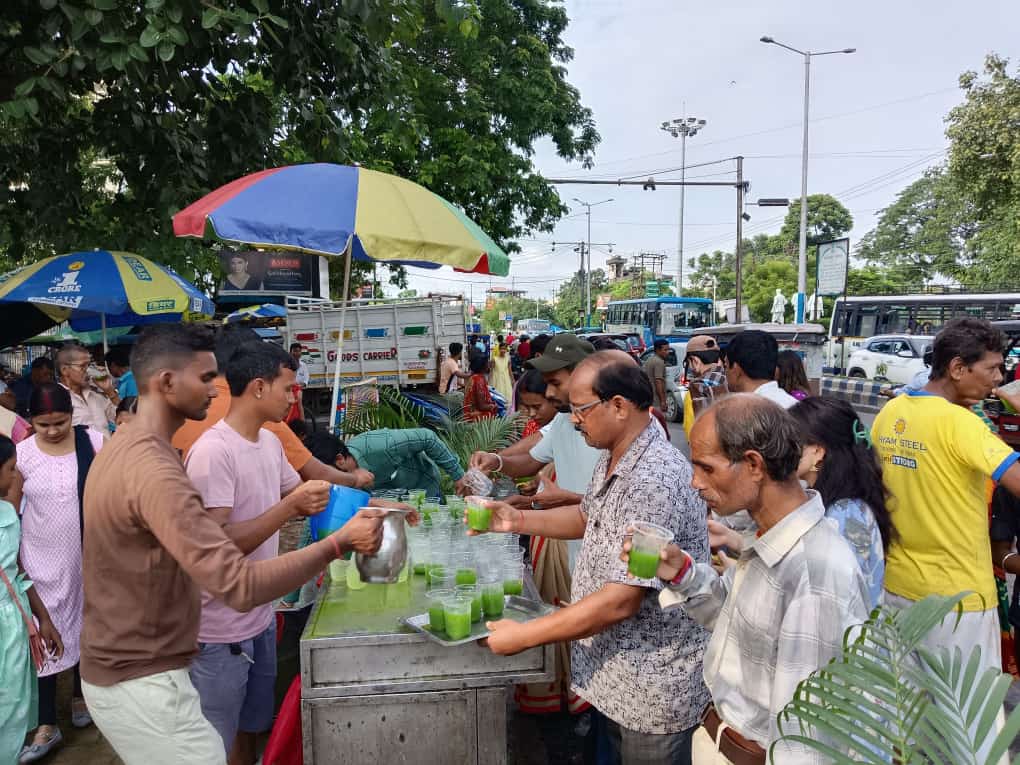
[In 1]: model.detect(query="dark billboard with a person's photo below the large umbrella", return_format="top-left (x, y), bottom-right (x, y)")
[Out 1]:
top-left (219, 250), bottom-right (327, 299)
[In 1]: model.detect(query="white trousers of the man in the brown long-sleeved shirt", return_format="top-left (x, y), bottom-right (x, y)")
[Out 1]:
top-left (82, 669), bottom-right (226, 765)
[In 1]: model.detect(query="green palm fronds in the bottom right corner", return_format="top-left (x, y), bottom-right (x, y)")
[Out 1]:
top-left (773, 593), bottom-right (1020, 765)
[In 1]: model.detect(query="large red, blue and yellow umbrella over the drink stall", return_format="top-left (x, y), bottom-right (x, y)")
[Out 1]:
top-left (173, 163), bottom-right (510, 276)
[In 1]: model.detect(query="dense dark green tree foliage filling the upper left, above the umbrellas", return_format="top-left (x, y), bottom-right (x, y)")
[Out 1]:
top-left (0, 0), bottom-right (599, 293)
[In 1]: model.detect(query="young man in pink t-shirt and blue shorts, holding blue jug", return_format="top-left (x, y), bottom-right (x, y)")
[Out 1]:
top-left (185, 343), bottom-right (329, 765)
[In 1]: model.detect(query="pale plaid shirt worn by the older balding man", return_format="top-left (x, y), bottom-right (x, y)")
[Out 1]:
top-left (659, 491), bottom-right (870, 765)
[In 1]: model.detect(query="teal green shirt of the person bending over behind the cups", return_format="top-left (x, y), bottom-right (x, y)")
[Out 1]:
top-left (346, 427), bottom-right (464, 497)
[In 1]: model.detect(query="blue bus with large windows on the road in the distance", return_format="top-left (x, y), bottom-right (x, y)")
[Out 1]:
top-left (606, 298), bottom-right (715, 346)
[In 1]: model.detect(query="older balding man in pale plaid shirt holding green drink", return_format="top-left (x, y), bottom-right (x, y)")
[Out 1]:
top-left (625, 394), bottom-right (869, 765)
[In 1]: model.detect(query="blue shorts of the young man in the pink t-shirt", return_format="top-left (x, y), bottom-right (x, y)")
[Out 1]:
top-left (191, 622), bottom-right (276, 753)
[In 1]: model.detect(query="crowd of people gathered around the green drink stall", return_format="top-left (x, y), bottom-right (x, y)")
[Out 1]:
top-left (0, 319), bottom-right (1020, 765)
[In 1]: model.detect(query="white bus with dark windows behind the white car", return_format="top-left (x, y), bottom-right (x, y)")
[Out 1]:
top-left (825, 293), bottom-right (1020, 373)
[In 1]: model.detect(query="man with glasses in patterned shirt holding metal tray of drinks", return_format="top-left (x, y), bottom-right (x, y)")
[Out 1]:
top-left (471, 351), bottom-right (709, 765)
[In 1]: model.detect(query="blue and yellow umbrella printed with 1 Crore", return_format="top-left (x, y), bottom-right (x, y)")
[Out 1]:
top-left (0, 250), bottom-right (215, 345)
